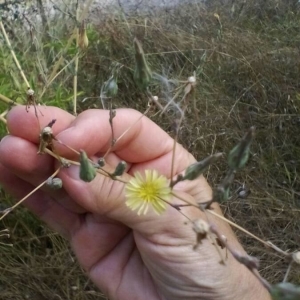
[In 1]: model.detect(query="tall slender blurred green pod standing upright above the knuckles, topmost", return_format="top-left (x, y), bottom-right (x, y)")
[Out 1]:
top-left (133, 38), bottom-right (152, 91)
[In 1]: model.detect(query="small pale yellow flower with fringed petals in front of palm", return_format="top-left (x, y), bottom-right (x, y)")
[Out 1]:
top-left (125, 170), bottom-right (171, 215)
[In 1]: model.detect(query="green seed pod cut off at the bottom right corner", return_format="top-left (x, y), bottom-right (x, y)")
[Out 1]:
top-left (270, 282), bottom-right (300, 300)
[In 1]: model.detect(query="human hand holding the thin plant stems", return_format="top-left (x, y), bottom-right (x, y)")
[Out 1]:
top-left (0, 106), bottom-right (270, 300)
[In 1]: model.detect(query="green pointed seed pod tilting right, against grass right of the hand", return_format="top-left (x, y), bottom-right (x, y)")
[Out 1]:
top-left (228, 127), bottom-right (254, 170)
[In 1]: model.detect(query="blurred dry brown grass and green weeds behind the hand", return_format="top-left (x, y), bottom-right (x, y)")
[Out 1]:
top-left (0, 0), bottom-right (300, 300)
